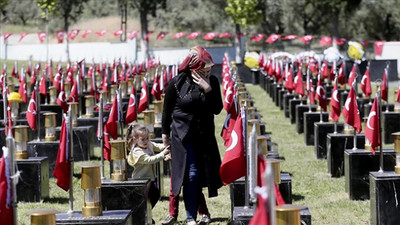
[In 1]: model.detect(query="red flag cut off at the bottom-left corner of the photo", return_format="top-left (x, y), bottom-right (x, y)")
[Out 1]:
top-left (0, 147), bottom-right (14, 225)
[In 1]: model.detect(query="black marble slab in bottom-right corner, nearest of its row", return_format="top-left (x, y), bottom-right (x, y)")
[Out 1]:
top-left (369, 172), bottom-right (400, 225)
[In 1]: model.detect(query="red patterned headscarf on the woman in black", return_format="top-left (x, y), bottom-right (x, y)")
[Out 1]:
top-left (178, 46), bottom-right (214, 72)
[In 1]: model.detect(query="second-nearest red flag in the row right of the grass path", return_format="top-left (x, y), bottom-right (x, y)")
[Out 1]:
top-left (342, 81), bottom-right (362, 133)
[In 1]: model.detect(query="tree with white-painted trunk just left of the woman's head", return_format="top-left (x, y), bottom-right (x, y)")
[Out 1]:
top-left (129, 0), bottom-right (166, 60)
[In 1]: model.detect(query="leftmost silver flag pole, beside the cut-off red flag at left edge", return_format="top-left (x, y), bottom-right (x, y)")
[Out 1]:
top-left (3, 127), bottom-right (19, 224)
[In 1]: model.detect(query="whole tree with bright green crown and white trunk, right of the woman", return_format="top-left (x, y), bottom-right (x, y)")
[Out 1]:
top-left (225, 0), bottom-right (262, 63)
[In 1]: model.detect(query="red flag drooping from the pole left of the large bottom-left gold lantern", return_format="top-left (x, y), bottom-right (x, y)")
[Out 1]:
top-left (53, 117), bottom-right (71, 191)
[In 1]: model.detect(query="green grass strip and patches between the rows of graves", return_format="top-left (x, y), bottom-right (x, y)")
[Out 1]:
top-left (18, 82), bottom-right (393, 225)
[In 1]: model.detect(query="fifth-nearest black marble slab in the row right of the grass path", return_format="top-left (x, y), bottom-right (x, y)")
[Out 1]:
top-left (303, 112), bottom-right (329, 145)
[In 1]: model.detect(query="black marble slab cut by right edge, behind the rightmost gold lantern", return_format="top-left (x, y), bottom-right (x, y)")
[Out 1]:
top-left (382, 111), bottom-right (400, 144)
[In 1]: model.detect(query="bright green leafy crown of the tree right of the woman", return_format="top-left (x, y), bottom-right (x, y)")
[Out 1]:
top-left (225, 0), bottom-right (262, 28)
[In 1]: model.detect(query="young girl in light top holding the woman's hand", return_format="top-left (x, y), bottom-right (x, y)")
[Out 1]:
top-left (126, 124), bottom-right (169, 213)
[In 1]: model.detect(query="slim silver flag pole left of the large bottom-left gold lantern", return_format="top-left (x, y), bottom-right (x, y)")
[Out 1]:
top-left (67, 106), bottom-right (74, 215)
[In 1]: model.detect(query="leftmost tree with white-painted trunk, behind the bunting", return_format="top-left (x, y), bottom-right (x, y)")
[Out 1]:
top-left (36, 0), bottom-right (88, 61)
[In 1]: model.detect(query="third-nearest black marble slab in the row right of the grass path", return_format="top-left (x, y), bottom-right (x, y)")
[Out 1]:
top-left (326, 133), bottom-right (365, 177)
